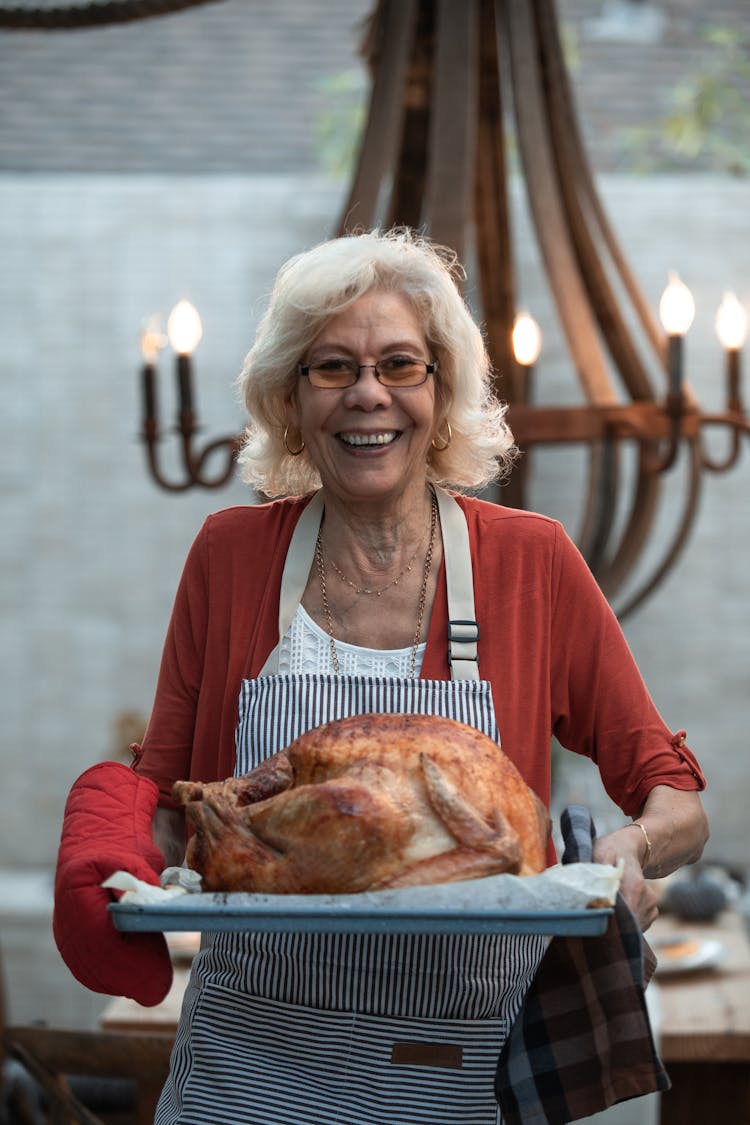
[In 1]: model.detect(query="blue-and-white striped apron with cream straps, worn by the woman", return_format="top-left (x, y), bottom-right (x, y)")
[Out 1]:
top-left (155, 492), bottom-right (546, 1125)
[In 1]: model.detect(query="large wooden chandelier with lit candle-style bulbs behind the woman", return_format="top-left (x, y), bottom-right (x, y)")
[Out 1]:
top-left (5, 0), bottom-right (750, 618)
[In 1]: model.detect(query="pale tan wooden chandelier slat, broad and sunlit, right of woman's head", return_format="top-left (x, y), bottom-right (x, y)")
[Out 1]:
top-left (506, 0), bottom-right (615, 404)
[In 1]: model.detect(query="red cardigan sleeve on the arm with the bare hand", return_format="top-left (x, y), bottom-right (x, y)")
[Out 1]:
top-left (551, 528), bottom-right (706, 816)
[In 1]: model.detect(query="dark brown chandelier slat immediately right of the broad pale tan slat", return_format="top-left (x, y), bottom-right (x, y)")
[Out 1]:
top-left (536, 0), bottom-right (663, 399)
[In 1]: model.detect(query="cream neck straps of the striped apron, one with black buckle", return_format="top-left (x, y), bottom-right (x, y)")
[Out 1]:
top-left (260, 487), bottom-right (479, 680)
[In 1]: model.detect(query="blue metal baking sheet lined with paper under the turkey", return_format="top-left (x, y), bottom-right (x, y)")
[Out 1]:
top-left (109, 893), bottom-right (612, 936)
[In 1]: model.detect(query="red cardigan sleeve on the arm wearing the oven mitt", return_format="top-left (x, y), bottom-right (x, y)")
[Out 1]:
top-left (133, 524), bottom-right (208, 807)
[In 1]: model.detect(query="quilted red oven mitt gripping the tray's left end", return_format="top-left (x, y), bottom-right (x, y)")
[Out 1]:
top-left (53, 762), bottom-right (172, 1006)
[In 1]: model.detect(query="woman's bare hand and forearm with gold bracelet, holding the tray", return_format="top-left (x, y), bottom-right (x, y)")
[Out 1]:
top-left (594, 785), bottom-right (708, 929)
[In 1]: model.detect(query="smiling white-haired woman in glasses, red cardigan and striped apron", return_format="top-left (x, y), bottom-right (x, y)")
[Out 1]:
top-left (56, 231), bottom-right (706, 1125)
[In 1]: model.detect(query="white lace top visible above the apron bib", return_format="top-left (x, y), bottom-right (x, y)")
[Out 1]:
top-left (279, 604), bottom-right (427, 678)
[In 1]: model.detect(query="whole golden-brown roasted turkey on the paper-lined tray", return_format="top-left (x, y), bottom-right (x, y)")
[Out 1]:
top-left (173, 714), bottom-right (550, 894)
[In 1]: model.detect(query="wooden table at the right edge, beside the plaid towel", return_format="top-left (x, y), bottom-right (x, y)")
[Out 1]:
top-left (647, 911), bottom-right (750, 1125)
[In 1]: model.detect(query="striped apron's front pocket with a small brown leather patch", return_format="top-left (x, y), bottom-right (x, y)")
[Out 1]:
top-left (173, 984), bottom-right (507, 1125)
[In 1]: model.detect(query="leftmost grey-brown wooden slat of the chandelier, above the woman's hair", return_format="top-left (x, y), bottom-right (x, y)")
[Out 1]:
top-left (337, 0), bottom-right (417, 235)
